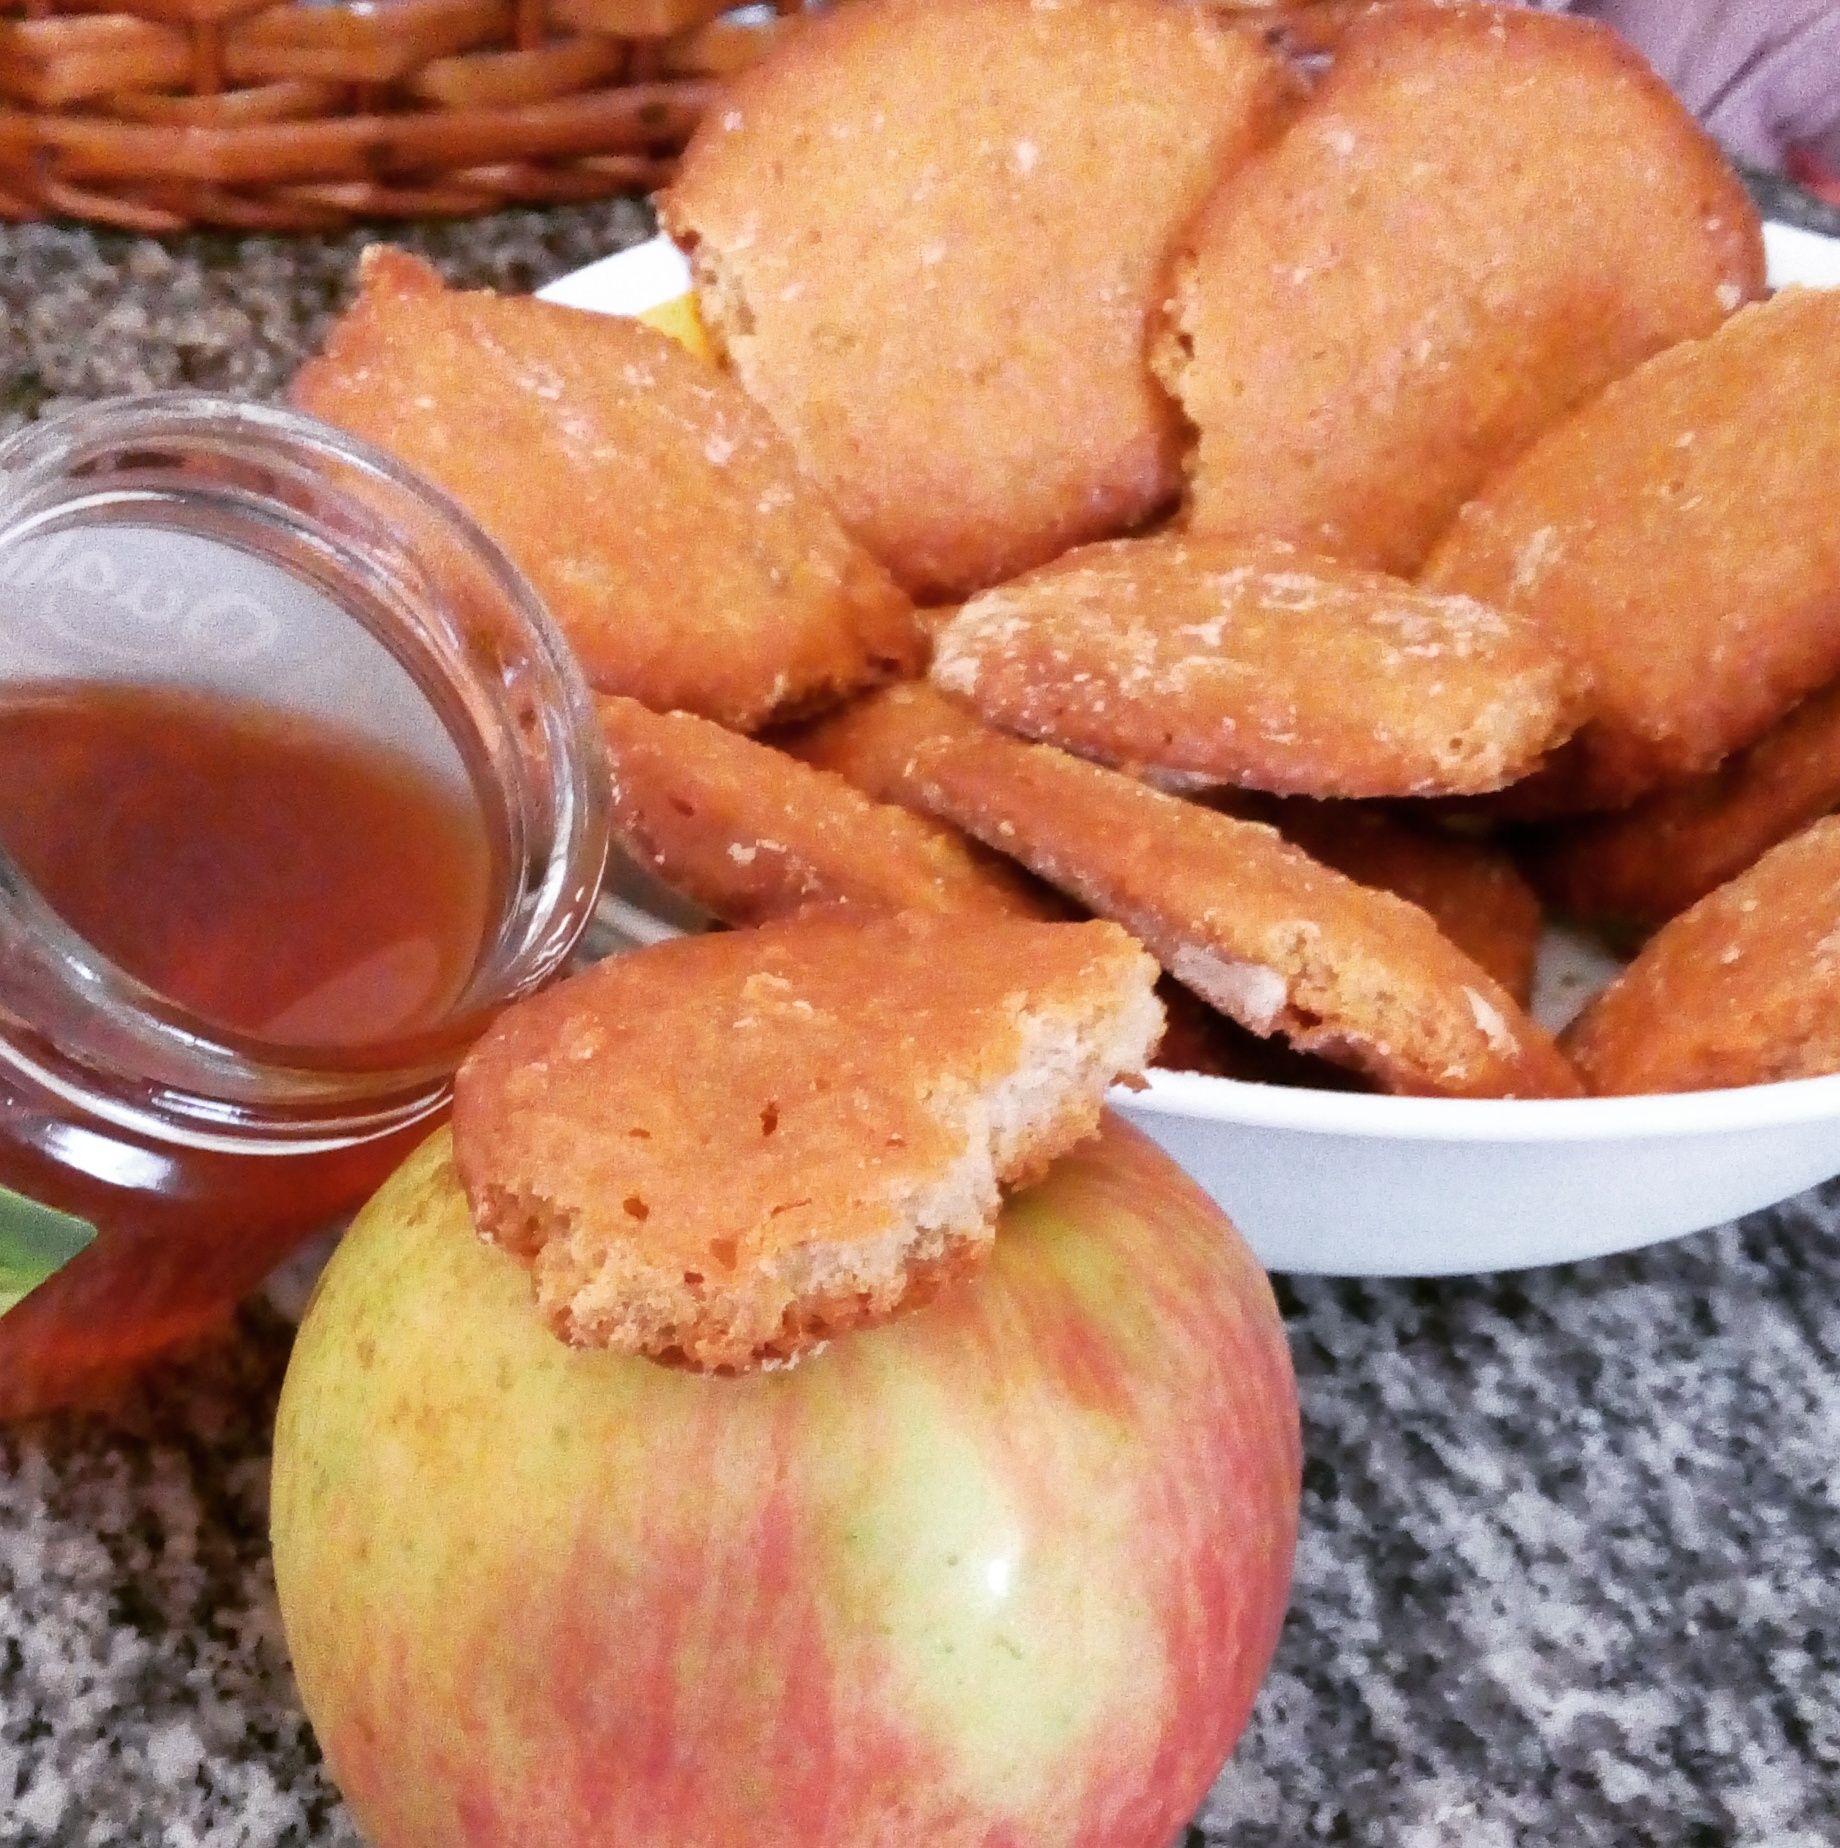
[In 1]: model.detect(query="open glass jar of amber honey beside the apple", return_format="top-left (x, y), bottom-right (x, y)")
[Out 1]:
top-left (0, 394), bottom-right (606, 1416)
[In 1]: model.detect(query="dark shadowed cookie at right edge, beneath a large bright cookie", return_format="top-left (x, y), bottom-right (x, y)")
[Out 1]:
top-left (1531, 682), bottom-right (1840, 928)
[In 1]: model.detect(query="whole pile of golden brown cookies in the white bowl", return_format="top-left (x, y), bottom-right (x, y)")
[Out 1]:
top-left (296, 0), bottom-right (1840, 1096)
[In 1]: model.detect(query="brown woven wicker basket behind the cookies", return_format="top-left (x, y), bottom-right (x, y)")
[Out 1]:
top-left (0, 0), bottom-right (800, 233)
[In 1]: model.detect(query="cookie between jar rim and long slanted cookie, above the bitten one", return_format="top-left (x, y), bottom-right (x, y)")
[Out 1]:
top-left (595, 697), bottom-right (1042, 924)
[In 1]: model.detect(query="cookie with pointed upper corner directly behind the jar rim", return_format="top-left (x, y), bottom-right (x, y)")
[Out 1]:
top-left (292, 248), bottom-right (926, 730)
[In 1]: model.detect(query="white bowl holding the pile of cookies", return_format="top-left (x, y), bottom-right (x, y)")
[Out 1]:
top-left (543, 225), bottom-right (1840, 1277)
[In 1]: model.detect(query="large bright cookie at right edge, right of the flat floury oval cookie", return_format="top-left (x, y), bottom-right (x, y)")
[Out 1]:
top-left (1424, 288), bottom-right (1840, 808)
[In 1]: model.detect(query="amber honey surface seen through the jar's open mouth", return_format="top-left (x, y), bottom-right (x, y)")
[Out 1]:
top-left (0, 682), bottom-right (493, 1050)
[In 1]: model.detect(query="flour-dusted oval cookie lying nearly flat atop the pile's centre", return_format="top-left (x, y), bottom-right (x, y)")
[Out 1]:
top-left (933, 534), bottom-right (1580, 796)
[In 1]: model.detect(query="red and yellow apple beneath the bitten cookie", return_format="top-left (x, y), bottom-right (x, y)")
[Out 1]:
top-left (273, 1116), bottom-right (1301, 1848)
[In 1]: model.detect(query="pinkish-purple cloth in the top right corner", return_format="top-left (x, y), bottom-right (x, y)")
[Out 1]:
top-left (1537, 0), bottom-right (1840, 172)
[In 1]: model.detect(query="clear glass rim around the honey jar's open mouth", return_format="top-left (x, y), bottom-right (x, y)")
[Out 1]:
top-left (0, 390), bottom-right (610, 1149)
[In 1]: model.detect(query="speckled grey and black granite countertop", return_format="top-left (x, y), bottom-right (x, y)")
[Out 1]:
top-left (0, 205), bottom-right (1840, 1848)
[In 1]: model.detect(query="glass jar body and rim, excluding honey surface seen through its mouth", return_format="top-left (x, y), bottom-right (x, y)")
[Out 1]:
top-left (0, 394), bottom-right (608, 1417)
